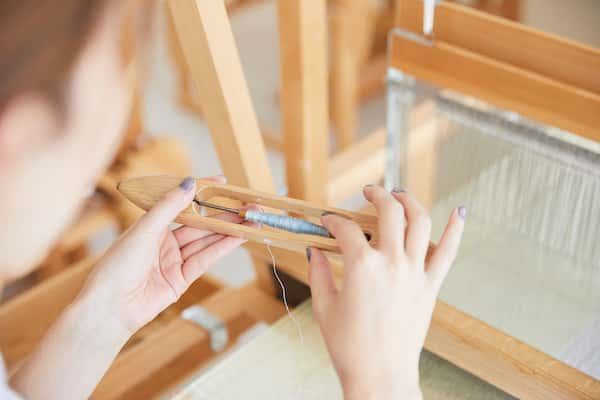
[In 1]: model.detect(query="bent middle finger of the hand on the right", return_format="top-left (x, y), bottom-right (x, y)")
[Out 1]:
top-left (363, 185), bottom-right (405, 252)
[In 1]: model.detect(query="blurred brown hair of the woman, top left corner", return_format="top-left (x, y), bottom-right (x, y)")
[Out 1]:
top-left (0, 0), bottom-right (112, 113)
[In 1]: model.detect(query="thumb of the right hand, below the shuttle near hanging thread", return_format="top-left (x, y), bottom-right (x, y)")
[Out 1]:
top-left (306, 247), bottom-right (337, 318)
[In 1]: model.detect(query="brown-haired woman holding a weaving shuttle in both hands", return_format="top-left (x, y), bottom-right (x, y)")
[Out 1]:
top-left (0, 0), bottom-right (465, 399)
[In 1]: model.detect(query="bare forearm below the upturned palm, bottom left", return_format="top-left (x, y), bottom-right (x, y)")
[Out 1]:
top-left (11, 293), bottom-right (130, 400)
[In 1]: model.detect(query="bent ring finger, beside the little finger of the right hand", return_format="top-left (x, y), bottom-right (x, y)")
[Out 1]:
top-left (392, 189), bottom-right (431, 264)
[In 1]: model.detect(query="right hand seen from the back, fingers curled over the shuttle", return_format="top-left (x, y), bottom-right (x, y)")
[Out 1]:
top-left (307, 185), bottom-right (466, 400)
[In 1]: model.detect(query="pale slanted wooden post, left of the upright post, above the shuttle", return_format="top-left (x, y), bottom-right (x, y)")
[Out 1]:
top-left (168, 0), bottom-right (275, 192)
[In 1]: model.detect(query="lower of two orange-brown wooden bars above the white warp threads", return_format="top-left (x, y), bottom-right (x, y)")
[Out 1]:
top-left (390, 31), bottom-right (600, 141)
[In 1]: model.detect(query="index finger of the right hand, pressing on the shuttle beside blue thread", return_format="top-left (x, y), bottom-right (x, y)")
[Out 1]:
top-left (321, 214), bottom-right (370, 262)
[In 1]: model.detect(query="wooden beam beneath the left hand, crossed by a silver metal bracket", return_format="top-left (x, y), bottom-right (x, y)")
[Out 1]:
top-left (94, 283), bottom-right (285, 399)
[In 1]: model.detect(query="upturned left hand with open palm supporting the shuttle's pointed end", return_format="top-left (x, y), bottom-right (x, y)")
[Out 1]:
top-left (82, 177), bottom-right (245, 334)
